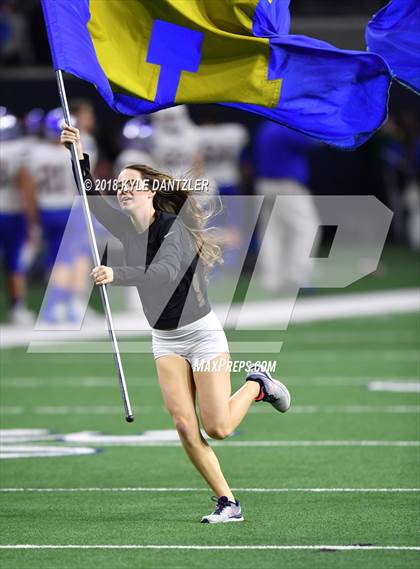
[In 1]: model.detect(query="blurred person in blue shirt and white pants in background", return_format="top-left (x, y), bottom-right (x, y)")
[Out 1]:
top-left (254, 121), bottom-right (319, 293)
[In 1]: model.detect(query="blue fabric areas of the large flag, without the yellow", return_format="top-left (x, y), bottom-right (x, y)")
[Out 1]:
top-left (42, 0), bottom-right (391, 149)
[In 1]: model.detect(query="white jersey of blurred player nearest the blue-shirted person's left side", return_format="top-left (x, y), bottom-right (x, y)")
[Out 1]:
top-left (198, 123), bottom-right (248, 186)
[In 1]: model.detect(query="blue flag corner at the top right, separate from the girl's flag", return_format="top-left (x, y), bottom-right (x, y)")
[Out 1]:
top-left (366, 0), bottom-right (420, 94)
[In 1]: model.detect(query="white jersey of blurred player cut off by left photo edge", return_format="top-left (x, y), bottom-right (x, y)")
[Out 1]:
top-left (0, 138), bottom-right (28, 214)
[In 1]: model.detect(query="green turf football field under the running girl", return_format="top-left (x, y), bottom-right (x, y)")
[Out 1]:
top-left (0, 304), bottom-right (420, 569)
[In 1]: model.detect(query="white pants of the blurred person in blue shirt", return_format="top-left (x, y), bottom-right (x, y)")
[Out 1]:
top-left (256, 178), bottom-right (319, 292)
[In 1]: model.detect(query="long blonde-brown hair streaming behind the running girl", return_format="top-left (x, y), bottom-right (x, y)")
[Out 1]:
top-left (124, 164), bottom-right (223, 272)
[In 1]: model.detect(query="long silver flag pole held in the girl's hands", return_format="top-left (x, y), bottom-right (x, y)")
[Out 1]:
top-left (55, 69), bottom-right (134, 423)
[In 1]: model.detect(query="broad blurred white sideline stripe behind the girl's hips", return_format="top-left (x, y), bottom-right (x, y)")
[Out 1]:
top-left (0, 288), bottom-right (420, 353)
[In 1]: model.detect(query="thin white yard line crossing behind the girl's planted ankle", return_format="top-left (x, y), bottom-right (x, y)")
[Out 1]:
top-left (0, 487), bottom-right (420, 494)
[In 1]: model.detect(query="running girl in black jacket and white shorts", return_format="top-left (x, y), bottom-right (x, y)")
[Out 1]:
top-left (61, 125), bottom-right (290, 523)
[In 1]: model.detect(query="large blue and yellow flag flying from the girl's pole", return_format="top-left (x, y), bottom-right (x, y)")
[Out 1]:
top-left (42, 0), bottom-right (390, 148)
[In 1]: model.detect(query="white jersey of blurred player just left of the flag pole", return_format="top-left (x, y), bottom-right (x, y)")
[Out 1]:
top-left (28, 141), bottom-right (77, 210)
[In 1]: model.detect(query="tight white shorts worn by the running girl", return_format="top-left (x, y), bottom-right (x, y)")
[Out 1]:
top-left (152, 310), bottom-right (229, 369)
